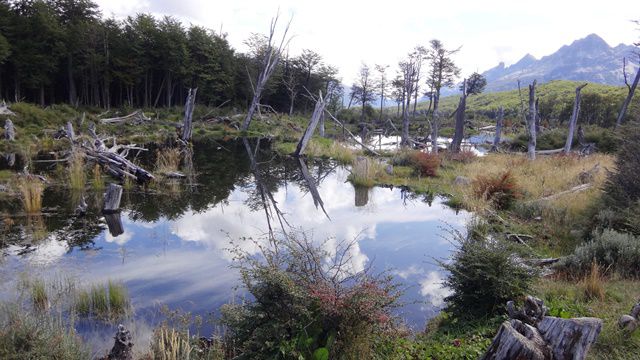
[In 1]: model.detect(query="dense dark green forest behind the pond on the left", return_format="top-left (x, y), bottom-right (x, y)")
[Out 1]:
top-left (0, 0), bottom-right (342, 112)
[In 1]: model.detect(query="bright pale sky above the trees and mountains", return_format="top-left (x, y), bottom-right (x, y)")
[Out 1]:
top-left (97, 0), bottom-right (640, 83)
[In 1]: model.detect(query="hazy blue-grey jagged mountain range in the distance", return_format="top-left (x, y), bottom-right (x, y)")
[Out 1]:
top-left (483, 34), bottom-right (640, 92)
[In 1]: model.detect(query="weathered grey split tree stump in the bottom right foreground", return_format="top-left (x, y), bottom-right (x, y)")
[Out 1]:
top-left (482, 296), bottom-right (602, 360)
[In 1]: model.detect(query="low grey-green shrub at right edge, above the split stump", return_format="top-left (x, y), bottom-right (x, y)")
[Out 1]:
top-left (557, 229), bottom-right (640, 278)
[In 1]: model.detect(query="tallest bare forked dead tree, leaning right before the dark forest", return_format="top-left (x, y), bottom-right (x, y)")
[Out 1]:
top-left (242, 15), bottom-right (291, 131)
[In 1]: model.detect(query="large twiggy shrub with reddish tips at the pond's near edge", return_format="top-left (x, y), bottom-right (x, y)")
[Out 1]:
top-left (222, 233), bottom-right (399, 359)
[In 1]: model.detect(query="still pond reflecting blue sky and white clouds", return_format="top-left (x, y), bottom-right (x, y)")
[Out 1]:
top-left (0, 140), bottom-right (469, 351)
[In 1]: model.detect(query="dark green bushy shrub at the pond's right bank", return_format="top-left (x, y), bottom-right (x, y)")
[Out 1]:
top-left (439, 224), bottom-right (536, 318)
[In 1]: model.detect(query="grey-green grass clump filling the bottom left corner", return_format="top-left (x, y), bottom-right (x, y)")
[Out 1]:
top-left (0, 305), bottom-right (91, 360)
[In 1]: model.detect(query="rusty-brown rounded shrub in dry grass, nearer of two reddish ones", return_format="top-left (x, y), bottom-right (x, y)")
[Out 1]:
top-left (471, 170), bottom-right (522, 210)
